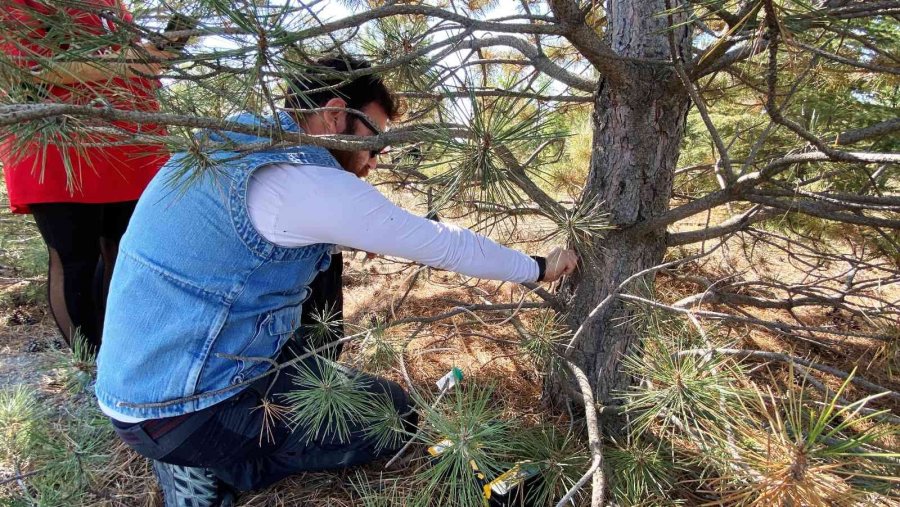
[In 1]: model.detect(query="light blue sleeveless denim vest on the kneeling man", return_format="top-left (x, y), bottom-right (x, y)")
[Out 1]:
top-left (95, 113), bottom-right (340, 419)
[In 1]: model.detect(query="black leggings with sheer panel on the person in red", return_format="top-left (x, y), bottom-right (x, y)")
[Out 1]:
top-left (29, 201), bottom-right (137, 351)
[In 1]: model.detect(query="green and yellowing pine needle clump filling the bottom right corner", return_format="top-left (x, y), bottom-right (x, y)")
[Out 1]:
top-left (616, 311), bottom-right (900, 507)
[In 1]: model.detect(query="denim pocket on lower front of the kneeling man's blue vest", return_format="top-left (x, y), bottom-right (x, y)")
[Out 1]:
top-left (235, 305), bottom-right (300, 379)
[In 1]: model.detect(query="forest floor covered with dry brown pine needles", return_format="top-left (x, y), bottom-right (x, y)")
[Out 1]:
top-left (0, 193), bottom-right (900, 506)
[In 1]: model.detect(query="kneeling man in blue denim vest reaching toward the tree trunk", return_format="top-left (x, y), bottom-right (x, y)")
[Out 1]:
top-left (96, 59), bottom-right (576, 507)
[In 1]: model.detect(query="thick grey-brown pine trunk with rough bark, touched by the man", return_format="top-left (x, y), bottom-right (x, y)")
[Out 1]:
top-left (551, 0), bottom-right (690, 404)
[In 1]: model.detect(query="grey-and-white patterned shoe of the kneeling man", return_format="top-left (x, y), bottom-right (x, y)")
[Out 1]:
top-left (153, 460), bottom-right (234, 507)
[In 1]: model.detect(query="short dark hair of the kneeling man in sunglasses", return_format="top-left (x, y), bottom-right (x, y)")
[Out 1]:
top-left (284, 57), bottom-right (400, 120)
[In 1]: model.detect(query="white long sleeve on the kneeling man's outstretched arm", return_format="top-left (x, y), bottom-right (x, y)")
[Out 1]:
top-left (247, 164), bottom-right (538, 282)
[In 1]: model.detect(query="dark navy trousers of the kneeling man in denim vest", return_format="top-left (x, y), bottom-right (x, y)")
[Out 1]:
top-left (113, 259), bottom-right (418, 491)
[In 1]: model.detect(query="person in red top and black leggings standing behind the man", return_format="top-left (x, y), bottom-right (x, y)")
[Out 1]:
top-left (0, 0), bottom-right (168, 351)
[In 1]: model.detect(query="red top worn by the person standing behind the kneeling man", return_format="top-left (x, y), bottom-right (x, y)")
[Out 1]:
top-left (0, 0), bottom-right (168, 213)
